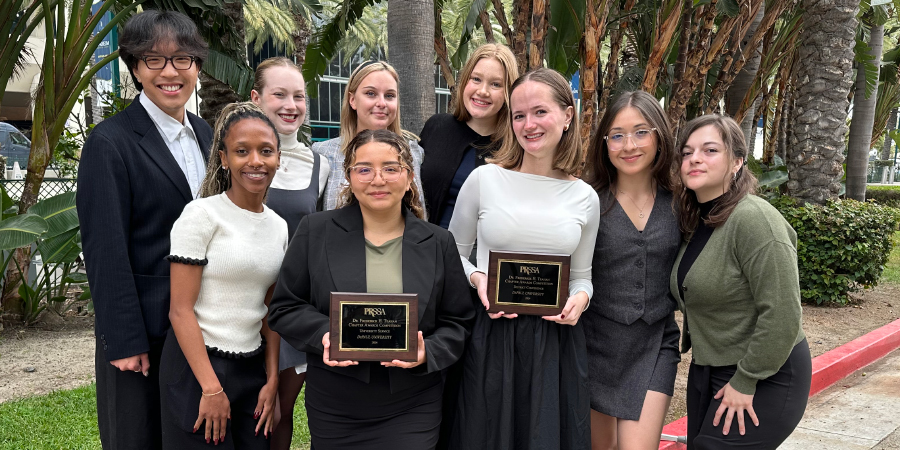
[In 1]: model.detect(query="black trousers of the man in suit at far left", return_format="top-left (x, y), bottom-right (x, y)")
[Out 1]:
top-left (94, 339), bottom-right (163, 450)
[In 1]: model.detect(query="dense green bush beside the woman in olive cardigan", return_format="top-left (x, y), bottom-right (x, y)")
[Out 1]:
top-left (771, 197), bottom-right (900, 304)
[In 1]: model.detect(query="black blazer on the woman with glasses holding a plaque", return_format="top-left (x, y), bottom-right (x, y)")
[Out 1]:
top-left (269, 204), bottom-right (475, 392)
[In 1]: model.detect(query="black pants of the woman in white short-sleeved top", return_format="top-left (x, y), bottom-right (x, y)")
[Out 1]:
top-left (159, 330), bottom-right (269, 450)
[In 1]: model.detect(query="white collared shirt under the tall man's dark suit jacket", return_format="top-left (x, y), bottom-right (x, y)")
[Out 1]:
top-left (139, 95), bottom-right (206, 198)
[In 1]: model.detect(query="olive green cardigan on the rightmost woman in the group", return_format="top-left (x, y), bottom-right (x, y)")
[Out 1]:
top-left (669, 195), bottom-right (805, 395)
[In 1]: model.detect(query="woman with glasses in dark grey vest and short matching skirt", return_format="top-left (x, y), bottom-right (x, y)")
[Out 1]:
top-left (582, 91), bottom-right (681, 450)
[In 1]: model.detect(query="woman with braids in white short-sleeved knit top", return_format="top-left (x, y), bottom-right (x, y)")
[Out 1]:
top-left (159, 102), bottom-right (288, 450)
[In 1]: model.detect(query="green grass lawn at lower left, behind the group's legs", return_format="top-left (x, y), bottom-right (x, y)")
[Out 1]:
top-left (0, 384), bottom-right (309, 450)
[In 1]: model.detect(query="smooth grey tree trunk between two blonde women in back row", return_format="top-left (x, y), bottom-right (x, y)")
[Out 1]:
top-left (388, 0), bottom-right (435, 133)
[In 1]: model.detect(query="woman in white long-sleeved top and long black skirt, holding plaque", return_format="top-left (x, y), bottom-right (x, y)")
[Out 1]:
top-left (450, 68), bottom-right (600, 450)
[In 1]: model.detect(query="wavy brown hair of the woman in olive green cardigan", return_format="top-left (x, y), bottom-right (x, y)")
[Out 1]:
top-left (676, 114), bottom-right (756, 236)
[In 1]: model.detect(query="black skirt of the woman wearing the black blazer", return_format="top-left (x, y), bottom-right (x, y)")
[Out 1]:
top-left (306, 362), bottom-right (441, 450)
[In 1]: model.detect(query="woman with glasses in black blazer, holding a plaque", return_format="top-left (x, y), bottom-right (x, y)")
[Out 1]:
top-left (269, 130), bottom-right (475, 450)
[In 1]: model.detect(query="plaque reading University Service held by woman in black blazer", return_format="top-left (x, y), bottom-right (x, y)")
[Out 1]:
top-left (329, 292), bottom-right (419, 362)
